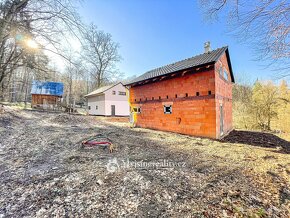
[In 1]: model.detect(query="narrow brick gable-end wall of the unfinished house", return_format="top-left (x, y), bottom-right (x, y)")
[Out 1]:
top-left (215, 54), bottom-right (233, 138)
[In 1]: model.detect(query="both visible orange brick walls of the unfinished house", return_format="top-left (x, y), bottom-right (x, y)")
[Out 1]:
top-left (130, 54), bottom-right (232, 138)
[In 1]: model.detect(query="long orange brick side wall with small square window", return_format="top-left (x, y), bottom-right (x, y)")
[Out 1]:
top-left (130, 68), bottom-right (216, 138)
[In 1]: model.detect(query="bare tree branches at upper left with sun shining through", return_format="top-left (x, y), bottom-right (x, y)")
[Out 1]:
top-left (0, 0), bottom-right (82, 100)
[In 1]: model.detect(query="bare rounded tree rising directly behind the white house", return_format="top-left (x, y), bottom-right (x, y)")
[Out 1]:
top-left (82, 24), bottom-right (121, 87)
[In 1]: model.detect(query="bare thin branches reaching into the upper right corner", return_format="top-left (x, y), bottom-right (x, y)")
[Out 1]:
top-left (200, 0), bottom-right (290, 76)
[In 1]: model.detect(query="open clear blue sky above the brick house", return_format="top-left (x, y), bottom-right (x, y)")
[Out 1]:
top-left (80, 0), bottom-right (275, 82)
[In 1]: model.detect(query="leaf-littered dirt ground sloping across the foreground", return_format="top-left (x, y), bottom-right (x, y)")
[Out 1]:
top-left (0, 107), bottom-right (290, 217)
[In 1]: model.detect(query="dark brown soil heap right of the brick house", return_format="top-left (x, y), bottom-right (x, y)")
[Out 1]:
top-left (221, 130), bottom-right (290, 153)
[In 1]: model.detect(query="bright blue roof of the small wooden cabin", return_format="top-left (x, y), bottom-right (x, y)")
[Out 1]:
top-left (31, 80), bottom-right (63, 96)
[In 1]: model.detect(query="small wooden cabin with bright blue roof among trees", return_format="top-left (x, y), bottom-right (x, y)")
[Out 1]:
top-left (31, 80), bottom-right (63, 110)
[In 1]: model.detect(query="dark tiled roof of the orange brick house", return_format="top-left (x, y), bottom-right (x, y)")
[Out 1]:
top-left (126, 46), bottom-right (234, 85)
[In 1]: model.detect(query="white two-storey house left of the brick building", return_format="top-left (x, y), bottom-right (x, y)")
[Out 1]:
top-left (85, 83), bottom-right (130, 116)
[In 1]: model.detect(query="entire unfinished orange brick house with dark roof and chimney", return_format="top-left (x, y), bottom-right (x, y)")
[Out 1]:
top-left (126, 43), bottom-right (235, 138)
